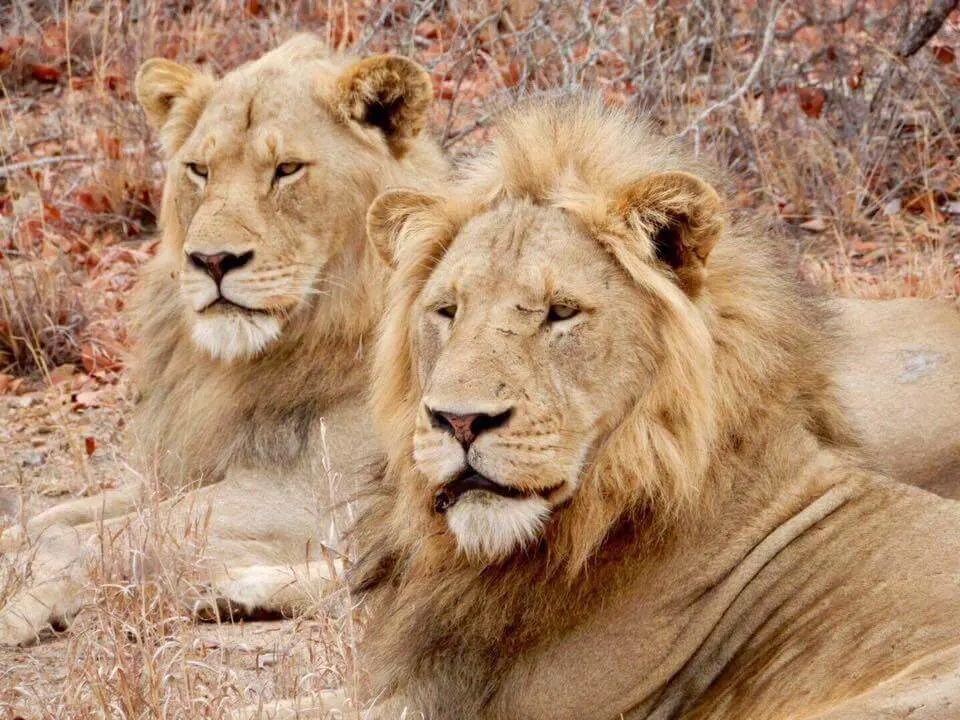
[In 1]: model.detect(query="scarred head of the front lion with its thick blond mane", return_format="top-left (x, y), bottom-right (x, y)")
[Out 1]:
top-left (368, 102), bottom-right (852, 568)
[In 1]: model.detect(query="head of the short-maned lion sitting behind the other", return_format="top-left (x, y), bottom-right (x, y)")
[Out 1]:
top-left (137, 36), bottom-right (440, 361)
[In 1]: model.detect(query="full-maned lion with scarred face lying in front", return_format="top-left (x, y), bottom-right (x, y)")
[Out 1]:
top-left (322, 100), bottom-right (960, 719)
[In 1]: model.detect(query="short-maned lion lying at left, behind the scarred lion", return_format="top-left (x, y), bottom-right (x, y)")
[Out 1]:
top-left (0, 36), bottom-right (446, 644)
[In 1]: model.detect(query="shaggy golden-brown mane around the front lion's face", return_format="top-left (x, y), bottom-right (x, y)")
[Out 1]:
top-left (356, 94), bottom-right (856, 717)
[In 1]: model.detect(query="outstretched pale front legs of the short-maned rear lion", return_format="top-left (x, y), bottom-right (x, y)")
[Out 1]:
top-left (0, 475), bottom-right (342, 645)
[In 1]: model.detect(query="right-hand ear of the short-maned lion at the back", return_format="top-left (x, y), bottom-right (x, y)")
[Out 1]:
top-left (336, 55), bottom-right (433, 156)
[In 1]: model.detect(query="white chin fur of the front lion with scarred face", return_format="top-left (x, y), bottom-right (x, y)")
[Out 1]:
top-left (446, 492), bottom-right (550, 561)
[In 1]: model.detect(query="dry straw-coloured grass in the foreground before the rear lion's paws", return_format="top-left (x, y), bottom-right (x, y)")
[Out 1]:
top-left (0, 476), bottom-right (356, 719)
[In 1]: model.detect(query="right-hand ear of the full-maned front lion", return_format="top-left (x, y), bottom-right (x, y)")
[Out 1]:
top-left (616, 172), bottom-right (724, 294)
